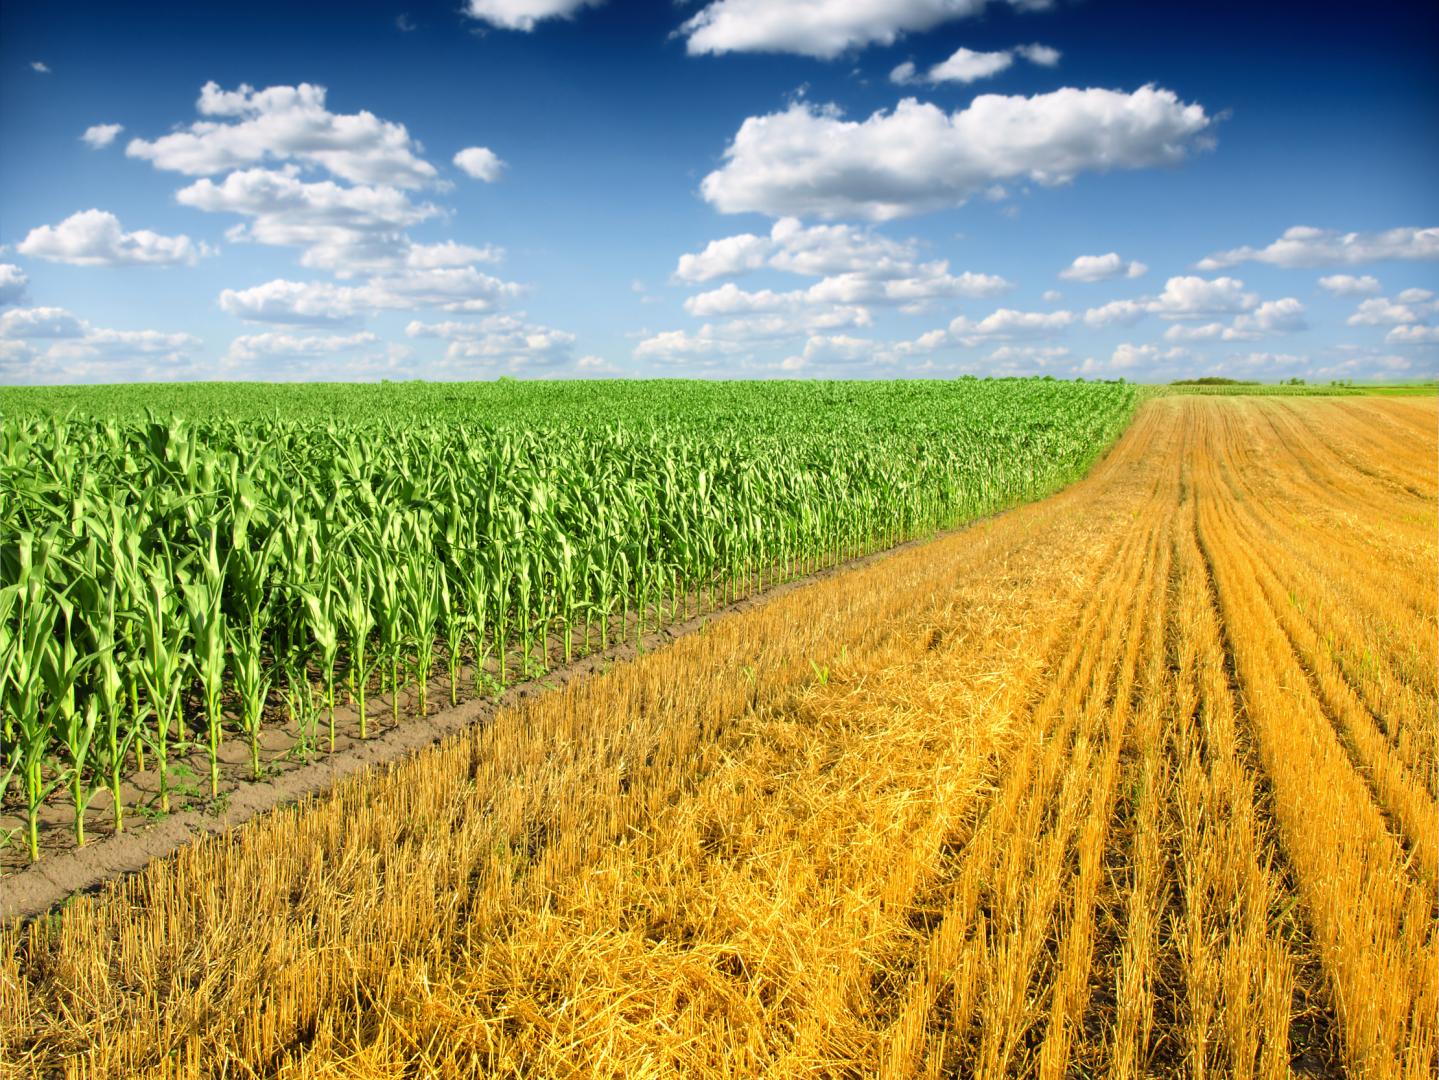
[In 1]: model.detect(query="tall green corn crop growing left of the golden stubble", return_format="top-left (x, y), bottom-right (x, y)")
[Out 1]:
top-left (0, 378), bottom-right (1135, 860)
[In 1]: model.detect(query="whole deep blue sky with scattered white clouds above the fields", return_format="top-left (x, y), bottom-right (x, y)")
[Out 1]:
top-left (0, 0), bottom-right (1439, 383)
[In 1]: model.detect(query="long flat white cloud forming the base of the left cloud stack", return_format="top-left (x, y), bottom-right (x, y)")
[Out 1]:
top-left (220, 266), bottom-right (524, 326)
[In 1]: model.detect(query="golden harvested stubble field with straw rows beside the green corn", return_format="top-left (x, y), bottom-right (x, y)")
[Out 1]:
top-left (0, 395), bottom-right (1439, 1077)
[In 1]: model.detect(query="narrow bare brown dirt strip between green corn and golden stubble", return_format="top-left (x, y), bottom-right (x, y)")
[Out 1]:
top-left (0, 506), bottom-right (1018, 923)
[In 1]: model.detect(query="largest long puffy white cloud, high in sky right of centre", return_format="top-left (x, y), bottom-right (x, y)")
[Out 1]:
top-left (701, 86), bottom-right (1213, 220)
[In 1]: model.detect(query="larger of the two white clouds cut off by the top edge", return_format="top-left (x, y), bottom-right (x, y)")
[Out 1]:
top-left (679, 0), bottom-right (1049, 59)
